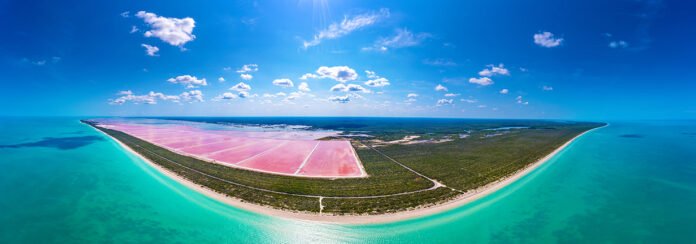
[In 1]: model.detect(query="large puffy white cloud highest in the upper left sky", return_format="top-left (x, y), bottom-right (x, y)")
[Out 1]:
top-left (136, 11), bottom-right (196, 47)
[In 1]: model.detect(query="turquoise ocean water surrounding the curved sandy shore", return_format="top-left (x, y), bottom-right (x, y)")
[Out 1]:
top-left (0, 118), bottom-right (696, 243)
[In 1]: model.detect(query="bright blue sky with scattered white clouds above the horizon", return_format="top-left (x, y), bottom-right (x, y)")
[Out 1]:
top-left (0, 0), bottom-right (696, 120)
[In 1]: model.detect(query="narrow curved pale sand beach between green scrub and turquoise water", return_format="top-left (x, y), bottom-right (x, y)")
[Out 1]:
top-left (90, 124), bottom-right (609, 224)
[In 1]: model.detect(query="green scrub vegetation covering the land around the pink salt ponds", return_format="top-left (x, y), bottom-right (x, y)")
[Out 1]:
top-left (83, 120), bottom-right (601, 214)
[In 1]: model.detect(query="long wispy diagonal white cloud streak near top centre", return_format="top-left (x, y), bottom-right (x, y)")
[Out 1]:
top-left (302, 8), bottom-right (389, 49)
